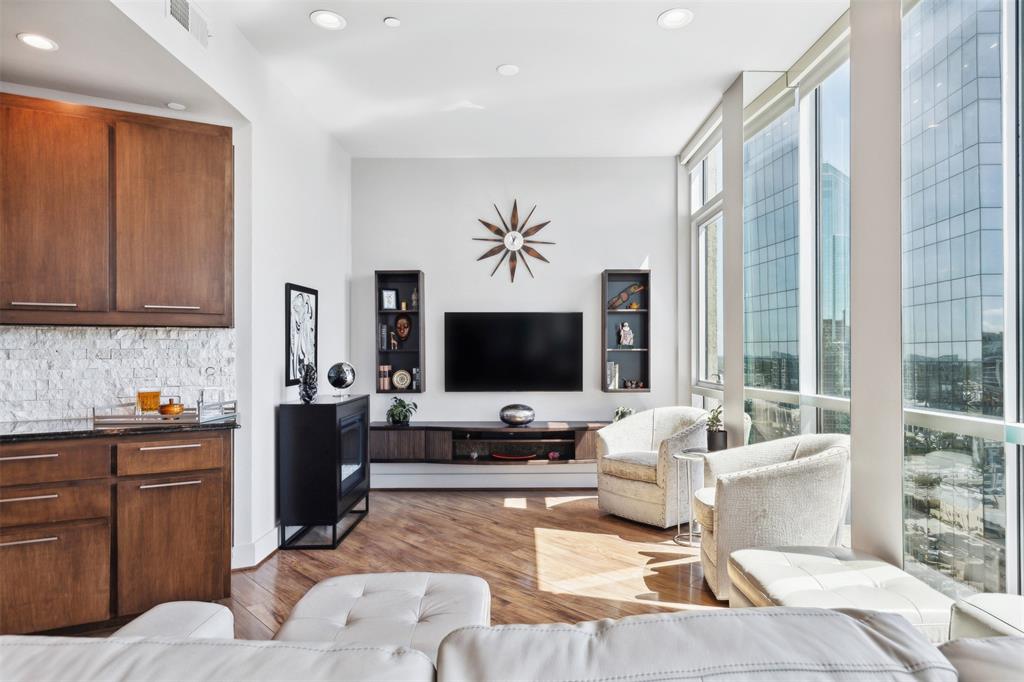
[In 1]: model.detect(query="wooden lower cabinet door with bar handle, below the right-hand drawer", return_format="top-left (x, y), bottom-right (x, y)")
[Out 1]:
top-left (118, 471), bottom-right (226, 615)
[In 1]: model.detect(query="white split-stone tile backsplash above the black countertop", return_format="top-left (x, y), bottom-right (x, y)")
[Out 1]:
top-left (0, 327), bottom-right (237, 422)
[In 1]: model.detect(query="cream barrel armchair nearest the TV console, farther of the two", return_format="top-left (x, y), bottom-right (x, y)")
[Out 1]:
top-left (597, 408), bottom-right (708, 528)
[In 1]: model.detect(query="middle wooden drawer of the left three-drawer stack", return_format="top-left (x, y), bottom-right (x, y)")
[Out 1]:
top-left (0, 480), bottom-right (111, 528)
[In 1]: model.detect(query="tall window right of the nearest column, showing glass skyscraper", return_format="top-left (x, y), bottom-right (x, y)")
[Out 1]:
top-left (902, 0), bottom-right (1020, 595)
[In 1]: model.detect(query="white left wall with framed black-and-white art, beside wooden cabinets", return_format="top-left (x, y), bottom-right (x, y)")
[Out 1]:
top-left (111, 0), bottom-right (351, 566)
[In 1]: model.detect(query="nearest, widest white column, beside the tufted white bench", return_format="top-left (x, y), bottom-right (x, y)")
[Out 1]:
top-left (850, 0), bottom-right (903, 566)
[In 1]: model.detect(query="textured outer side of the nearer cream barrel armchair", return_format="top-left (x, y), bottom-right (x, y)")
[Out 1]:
top-left (715, 447), bottom-right (850, 560)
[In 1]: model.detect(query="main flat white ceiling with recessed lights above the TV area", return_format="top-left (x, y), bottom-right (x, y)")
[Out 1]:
top-left (218, 0), bottom-right (848, 157)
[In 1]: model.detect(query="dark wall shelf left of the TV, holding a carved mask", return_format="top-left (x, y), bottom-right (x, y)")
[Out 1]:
top-left (374, 270), bottom-right (426, 394)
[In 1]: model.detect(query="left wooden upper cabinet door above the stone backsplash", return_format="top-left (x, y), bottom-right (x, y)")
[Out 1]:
top-left (0, 106), bottom-right (111, 314)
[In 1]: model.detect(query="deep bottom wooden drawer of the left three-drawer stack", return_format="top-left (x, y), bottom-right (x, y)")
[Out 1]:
top-left (0, 519), bottom-right (111, 633)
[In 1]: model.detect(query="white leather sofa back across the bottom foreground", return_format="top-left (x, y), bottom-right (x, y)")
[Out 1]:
top-left (0, 604), bottom-right (1003, 682)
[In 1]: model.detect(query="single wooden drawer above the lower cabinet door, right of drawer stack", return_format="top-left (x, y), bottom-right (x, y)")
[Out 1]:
top-left (118, 436), bottom-right (224, 476)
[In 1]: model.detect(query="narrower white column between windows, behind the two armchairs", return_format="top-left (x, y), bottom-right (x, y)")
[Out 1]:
top-left (720, 74), bottom-right (743, 445)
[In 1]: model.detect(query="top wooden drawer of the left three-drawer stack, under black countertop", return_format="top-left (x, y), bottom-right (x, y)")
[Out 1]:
top-left (0, 440), bottom-right (111, 485)
